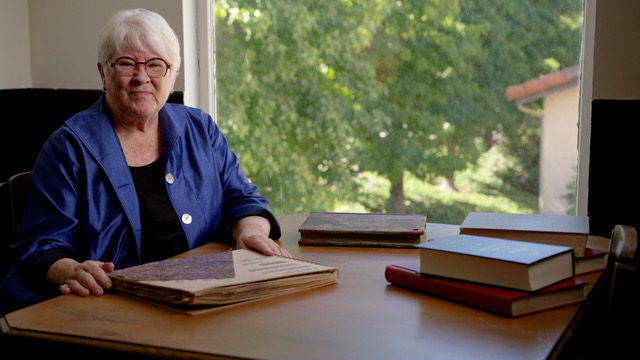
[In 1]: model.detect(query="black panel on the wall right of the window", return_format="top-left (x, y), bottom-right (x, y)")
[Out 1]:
top-left (587, 100), bottom-right (640, 237)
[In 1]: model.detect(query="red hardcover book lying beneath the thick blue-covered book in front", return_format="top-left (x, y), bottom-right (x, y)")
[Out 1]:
top-left (385, 260), bottom-right (587, 317)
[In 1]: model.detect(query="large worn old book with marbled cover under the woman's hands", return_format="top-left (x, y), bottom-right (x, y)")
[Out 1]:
top-left (108, 249), bottom-right (338, 310)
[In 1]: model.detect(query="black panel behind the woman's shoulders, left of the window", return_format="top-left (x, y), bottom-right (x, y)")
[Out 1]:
top-left (0, 89), bottom-right (183, 181)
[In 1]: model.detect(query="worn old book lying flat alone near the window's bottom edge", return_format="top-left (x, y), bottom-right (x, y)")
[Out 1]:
top-left (298, 212), bottom-right (427, 247)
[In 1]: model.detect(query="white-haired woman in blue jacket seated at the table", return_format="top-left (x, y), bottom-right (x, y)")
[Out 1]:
top-left (2, 9), bottom-right (290, 312)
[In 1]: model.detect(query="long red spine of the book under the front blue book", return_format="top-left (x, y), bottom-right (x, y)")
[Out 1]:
top-left (385, 265), bottom-right (513, 317)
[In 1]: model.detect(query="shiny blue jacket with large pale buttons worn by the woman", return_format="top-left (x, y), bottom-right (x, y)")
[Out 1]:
top-left (0, 97), bottom-right (280, 316)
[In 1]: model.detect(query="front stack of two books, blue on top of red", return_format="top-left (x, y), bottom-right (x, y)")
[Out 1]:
top-left (385, 234), bottom-right (587, 317)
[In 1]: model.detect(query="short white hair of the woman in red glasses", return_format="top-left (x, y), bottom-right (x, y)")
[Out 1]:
top-left (98, 9), bottom-right (181, 71)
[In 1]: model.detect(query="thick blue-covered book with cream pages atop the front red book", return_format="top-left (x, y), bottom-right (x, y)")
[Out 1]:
top-left (418, 234), bottom-right (574, 291)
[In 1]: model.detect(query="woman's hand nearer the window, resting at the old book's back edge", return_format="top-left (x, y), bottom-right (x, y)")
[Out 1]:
top-left (231, 216), bottom-right (291, 257)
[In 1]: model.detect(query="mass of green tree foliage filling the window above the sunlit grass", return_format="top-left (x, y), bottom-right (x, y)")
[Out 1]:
top-left (216, 0), bottom-right (581, 213)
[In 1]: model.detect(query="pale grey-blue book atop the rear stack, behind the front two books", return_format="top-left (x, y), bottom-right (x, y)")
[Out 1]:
top-left (460, 212), bottom-right (589, 256)
